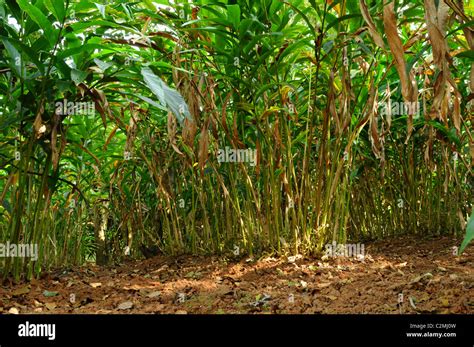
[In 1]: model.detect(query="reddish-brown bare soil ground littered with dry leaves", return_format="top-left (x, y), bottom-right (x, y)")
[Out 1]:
top-left (0, 237), bottom-right (474, 314)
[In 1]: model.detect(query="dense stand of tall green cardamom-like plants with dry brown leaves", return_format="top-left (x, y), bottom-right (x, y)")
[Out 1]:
top-left (0, 0), bottom-right (474, 278)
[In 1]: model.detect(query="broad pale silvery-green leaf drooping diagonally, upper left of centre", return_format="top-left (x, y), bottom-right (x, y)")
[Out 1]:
top-left (141, 67), bottom-right (191, 124)
